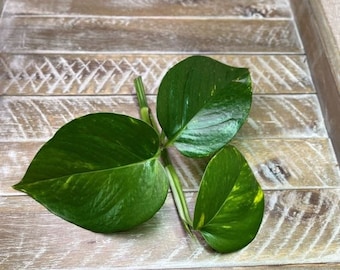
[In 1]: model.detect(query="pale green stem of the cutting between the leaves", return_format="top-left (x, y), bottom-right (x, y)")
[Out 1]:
top-left (134, 77), bottom-right (192, 232)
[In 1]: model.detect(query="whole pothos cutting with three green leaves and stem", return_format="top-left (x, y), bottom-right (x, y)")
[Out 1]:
top-left (13, 56), bottom-right (264, 253)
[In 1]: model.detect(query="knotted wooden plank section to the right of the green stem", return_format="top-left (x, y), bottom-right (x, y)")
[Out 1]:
top-left (172, 139), bottom-right (340, 190)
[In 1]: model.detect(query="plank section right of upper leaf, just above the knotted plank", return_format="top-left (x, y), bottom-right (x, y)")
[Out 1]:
top-left (237, 95), bottom-right (327, 138)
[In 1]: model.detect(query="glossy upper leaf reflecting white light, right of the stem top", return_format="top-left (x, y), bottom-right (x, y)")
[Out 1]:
top-left (157, 56), bottom-right (252, 157)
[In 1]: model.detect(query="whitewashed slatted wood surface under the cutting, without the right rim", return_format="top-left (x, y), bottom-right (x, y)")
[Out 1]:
top-left (0, 0), bottom-right (340, 269)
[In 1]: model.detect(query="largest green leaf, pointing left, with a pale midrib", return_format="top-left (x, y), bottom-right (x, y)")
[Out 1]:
top-left (14, 113), bottom-right (169, 233)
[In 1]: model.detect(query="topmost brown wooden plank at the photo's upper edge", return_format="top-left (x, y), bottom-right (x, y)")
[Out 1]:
top-left (5, 0), bottom-right (291, 18)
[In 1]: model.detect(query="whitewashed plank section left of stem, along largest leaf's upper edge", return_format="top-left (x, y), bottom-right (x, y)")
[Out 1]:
top-left (0, 96), bottom-right (139, 141)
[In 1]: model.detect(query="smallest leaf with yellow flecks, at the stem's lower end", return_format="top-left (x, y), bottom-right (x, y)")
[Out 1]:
top-left (193, 146), bottom-right (264, 253)
